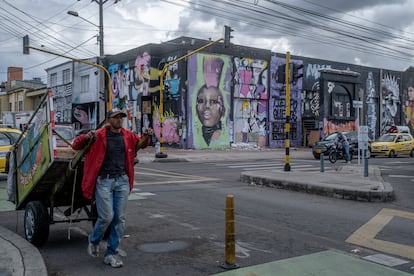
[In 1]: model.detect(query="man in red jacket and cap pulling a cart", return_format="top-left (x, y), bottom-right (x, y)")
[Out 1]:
top-left (72, 110), bottom-right (153, 267)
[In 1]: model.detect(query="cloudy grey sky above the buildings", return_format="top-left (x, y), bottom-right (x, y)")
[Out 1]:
top-left (0, 0), bottom-right (414, 82)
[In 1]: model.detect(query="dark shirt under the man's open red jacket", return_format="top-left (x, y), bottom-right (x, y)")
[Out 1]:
top-left (99, 129), bottom-right (125, 176)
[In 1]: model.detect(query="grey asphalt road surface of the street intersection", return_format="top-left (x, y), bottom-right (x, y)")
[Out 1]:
top-left (0, 158), bottom-right (414, 275)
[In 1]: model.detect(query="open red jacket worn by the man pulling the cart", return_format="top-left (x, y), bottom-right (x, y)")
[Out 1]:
top-left (72, 126), bottom-right (150, 199)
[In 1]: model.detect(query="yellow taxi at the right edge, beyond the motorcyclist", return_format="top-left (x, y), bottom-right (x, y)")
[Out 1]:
top-left (371, 133), bottom-right (414, 157)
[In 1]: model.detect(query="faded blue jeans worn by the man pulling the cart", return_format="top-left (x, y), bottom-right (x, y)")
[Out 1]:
top-left (89, 175), bottom-right (129, 256)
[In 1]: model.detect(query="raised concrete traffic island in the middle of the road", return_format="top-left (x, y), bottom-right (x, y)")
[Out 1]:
top-left (240, 164), bottom-right (394, 201)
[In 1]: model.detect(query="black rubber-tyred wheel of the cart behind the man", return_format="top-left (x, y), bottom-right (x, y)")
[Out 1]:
top-left (24, 201), bottom-right (49, 246)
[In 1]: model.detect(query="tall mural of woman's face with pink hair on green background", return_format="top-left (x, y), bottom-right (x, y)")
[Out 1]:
top-left (188, 54), bottom-right (231, 149)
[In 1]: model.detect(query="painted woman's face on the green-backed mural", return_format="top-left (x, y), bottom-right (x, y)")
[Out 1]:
top-left (197, 86), bottom-right (224, 127)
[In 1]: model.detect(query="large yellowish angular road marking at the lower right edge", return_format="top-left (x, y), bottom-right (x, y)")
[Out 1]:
top-left (346, 208), bottom-right (414, 260)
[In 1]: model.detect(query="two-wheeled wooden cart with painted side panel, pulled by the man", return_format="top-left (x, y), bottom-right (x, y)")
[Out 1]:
top-left (9, 92), bottom-right (96, 246)
